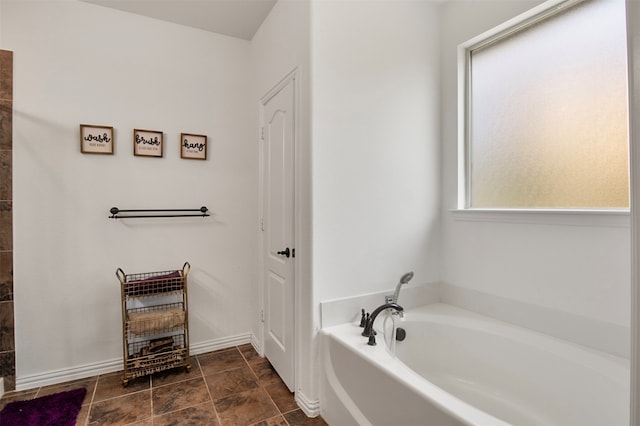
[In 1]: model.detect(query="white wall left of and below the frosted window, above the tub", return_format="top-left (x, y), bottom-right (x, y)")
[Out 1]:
top-left (442, 1), bottom-right (630, 327)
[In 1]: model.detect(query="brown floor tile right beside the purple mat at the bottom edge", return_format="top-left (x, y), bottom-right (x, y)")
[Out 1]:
top-left (88, 390), bottom-right (151, 426)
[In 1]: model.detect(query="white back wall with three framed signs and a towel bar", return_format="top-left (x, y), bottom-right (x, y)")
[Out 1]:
top-left (0, 0), bottom-right (258, 386)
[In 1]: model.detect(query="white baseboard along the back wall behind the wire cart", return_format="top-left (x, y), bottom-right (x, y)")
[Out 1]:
top-left (16, 333), bottom-right (253, 391)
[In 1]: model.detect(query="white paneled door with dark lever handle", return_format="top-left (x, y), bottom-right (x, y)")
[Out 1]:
top-left (262, 75), bottom-right (295, 392)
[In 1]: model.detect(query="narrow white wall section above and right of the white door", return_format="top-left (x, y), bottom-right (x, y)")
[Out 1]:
top-left (251, 0), bottom-right (317, 413)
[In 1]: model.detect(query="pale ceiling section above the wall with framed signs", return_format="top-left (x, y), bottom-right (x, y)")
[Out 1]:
top-left (82, 0), bottom-right (277, 40)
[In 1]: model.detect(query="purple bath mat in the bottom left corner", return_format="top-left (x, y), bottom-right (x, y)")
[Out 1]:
top-left (0, 388), bottom-right (87, 426)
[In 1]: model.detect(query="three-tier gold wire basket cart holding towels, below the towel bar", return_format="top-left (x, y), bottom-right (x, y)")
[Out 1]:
top-left (116, 262), bottom-right (191, 386)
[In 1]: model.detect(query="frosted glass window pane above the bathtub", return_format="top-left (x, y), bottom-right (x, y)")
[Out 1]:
top-left (467, 0), bottom-right (629, 209)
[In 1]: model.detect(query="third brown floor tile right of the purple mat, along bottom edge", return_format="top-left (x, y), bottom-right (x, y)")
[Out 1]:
top-left (213, 388), bottom-right (279, 426)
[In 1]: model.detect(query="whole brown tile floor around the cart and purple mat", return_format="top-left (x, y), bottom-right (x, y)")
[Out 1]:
top-left (0, 344), bottom-right (327, 426)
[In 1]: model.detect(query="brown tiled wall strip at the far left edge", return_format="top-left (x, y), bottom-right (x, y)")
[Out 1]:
top-left (0, 50), bottom-right (16, 391)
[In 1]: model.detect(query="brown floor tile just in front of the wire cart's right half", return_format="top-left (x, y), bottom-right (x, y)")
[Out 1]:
top-left (152, 378), bottom-right (211, 415)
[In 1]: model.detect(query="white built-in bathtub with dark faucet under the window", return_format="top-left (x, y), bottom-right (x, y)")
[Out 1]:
top-left (320, 304), bottom-right (630, 426)
